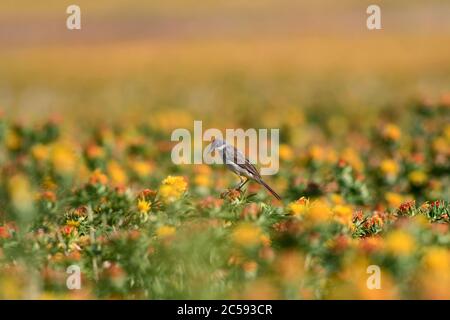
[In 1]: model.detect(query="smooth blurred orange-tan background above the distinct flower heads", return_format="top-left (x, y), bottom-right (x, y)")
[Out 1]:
top-left (0, 0), bottom-right (450, 127)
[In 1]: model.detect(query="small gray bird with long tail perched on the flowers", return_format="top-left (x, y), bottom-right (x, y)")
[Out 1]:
top-left (209, 139), bottom-right (281, 200)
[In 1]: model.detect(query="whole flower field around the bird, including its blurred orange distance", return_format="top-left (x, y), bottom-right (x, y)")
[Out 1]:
top-left (0, 0), bottom-right (450, 299)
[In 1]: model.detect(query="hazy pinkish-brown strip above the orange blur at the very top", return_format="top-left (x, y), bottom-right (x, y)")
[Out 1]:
top-left (0, 0), bottom-right (450, 48)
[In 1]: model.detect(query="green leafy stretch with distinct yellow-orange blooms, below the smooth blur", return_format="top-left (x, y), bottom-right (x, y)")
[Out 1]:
top-left (0, 97), bottom-right (450, 299)
